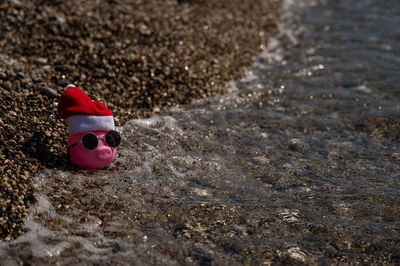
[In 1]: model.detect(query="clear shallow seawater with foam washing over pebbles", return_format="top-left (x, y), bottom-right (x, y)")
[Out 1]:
top-left (0, 0), bottom-right (400, 265)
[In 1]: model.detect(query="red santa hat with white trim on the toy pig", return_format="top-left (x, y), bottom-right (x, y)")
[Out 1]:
top-left (57, 84), bottom-right (115, 134)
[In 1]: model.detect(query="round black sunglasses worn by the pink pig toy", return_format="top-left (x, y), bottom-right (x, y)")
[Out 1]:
top-left (67, 130), bottom-right (121, 155)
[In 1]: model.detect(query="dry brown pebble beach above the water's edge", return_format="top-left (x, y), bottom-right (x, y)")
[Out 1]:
top-left (0, 0), bottom-right (281, 240)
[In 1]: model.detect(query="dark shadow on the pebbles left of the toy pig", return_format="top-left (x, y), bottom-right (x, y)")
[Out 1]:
top-left (22, 132), bottom-right (69, 169)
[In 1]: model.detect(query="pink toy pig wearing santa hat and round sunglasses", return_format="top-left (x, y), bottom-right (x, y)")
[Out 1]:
top-left (58, 85), bottom-right (121, 169)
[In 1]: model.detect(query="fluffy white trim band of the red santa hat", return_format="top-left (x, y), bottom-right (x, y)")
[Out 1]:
top-left (66, 115), bottom-right (115, 134)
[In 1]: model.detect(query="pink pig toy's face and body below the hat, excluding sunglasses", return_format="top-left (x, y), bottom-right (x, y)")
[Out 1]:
top-left (67, 130), bottom-right (116, 169)
